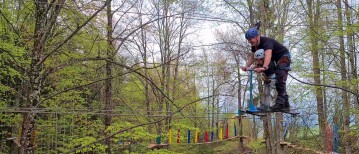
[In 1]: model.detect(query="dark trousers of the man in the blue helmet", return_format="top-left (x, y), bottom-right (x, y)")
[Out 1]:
top-left (275, 53), bottom-right (291, 107)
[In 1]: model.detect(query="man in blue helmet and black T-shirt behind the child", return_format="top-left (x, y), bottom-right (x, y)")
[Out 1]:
top-left (242, 28), bottom-right (291, 111)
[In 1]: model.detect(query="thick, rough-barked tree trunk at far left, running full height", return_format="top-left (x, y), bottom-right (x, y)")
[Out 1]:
top-left (20, 0), bottom-right (47, 154)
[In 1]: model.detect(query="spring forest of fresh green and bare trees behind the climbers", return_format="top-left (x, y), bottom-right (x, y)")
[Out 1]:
top-left (0, 0), bottom-right (359, 153)
